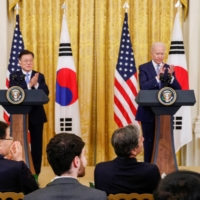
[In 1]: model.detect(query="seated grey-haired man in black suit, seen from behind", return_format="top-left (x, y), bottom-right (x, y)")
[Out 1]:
top-left (94, 125), bottom-right (161, 195)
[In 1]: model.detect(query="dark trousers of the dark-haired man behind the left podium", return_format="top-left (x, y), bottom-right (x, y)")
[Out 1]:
top-left (29, 121), bottom-right (43, 174)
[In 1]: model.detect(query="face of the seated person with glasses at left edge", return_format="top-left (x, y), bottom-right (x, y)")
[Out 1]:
top-left (0, 128), bottom-right (13, 156)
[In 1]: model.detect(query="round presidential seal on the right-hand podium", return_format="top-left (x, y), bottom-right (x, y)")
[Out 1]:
top-left (158, 87), bottom-right (177, 106)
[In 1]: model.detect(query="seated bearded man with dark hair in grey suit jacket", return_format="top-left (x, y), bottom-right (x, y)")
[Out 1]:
top-left (24, 133), bottom-right (107, 200)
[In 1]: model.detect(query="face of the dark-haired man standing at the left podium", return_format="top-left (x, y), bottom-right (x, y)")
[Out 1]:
top-left (19, 54), bottom-right (34, 72)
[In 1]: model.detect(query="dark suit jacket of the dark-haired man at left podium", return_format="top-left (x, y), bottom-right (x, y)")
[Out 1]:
top-left (9, 70), bottom-right (49, 125)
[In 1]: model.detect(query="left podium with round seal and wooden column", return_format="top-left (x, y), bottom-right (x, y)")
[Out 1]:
top-left (0, 86), bottom-right (49, 174)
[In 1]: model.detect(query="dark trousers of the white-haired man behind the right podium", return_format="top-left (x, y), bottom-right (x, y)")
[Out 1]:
top-left (141, 121), bottom-right (155, 163)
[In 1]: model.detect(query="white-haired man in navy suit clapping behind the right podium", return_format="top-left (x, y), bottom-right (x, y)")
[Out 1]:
top-left (136, 42), bottom-right (181, 163)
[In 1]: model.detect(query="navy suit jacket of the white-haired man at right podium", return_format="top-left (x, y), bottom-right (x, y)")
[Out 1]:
top-left (136, 61), bottom-right (181, 122)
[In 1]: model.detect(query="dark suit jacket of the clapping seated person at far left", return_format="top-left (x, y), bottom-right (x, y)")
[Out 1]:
top-left (0, 155), bottom-right (38, 194)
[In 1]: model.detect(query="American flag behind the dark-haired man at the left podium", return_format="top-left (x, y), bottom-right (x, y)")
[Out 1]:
top-left (3, 14), bottom-right (24, 123)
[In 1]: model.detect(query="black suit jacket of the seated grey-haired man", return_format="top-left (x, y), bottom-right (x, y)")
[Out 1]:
top-left (94, 157), bottom-right (160, 195)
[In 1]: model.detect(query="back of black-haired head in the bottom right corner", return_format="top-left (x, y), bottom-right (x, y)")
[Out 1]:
top-left (154, 170), bottom-right (200, 200)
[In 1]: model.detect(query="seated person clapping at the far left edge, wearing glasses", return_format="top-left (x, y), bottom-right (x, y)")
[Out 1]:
top-left (0, 121), bottom-right (38, 194)
